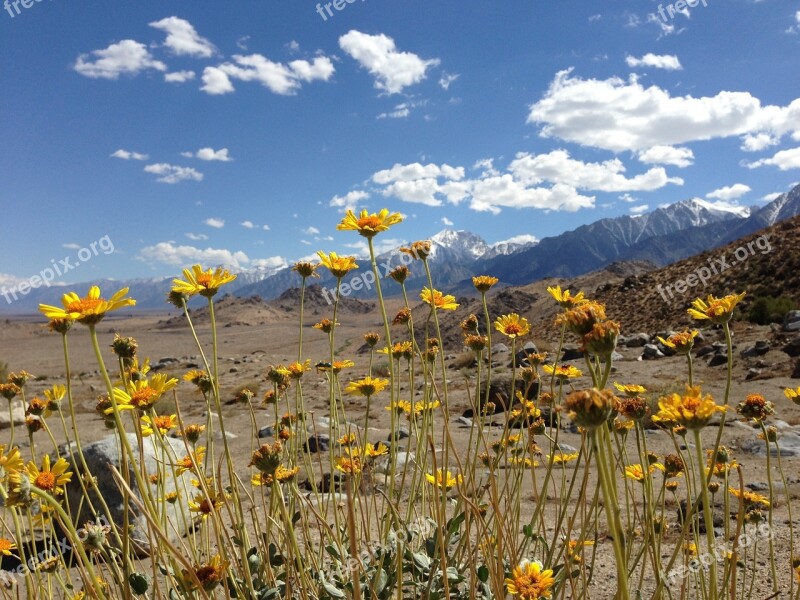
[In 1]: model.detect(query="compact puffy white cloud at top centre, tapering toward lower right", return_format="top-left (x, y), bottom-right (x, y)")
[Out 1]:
top-left (339, 29), bottom-right (440, 94)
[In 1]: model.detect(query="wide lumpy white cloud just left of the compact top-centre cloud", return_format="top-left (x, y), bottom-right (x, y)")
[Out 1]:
top-left (200, 54), bottom-right (335, 96)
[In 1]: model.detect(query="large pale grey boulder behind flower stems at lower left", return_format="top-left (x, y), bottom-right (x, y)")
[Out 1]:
top-left (61, 433), bottom-right (196, 556)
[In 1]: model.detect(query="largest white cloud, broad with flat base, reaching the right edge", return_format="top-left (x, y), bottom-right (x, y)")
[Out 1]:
top-left (528, 69), bottom-right (800, 152)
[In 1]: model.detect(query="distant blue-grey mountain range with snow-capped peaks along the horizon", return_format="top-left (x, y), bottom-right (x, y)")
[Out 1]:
top-left (0, 185), bottom-right (800, 313)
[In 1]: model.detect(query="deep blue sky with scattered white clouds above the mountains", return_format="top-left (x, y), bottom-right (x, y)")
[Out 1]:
top-left (0, 0), bottom-right (800, 284)
